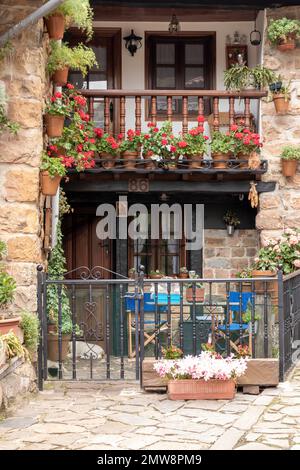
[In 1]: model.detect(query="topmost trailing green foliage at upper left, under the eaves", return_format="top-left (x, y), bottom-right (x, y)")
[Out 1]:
top-left (56, 0), bottom-right (94, 39)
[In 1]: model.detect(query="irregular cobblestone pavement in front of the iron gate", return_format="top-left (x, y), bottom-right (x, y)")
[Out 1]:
top-left (0, 367), bottom-right (300, 450)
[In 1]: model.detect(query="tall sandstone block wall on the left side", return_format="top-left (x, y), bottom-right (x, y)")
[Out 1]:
top-left (0, 0), bottom-right (49, 311)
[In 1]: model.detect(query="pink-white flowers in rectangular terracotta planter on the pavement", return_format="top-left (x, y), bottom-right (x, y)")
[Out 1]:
top-left (153, 351), bottom-right (247, 400)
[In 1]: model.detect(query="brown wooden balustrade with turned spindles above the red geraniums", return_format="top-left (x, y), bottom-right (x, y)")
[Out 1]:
top-left (81, 90), bottom-right (267, 134)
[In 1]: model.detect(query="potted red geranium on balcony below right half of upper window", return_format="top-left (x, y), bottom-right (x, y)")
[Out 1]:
top-left (177, 116), bottom-right (208, 169)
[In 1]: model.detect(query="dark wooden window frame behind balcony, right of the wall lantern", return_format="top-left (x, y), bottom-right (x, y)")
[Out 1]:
top-left (145, 31), bottom-right (216, 121)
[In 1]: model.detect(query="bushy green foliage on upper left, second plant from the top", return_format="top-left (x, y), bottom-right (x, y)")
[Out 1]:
top-left (47, 41), bottom-right (98, 76)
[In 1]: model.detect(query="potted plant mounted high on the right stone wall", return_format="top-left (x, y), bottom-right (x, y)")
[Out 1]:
top-left (268, 17), bottom-right (300, 52)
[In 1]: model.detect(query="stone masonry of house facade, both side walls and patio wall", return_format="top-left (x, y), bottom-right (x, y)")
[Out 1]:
top-left (0, 0), bottom-right (300, 312)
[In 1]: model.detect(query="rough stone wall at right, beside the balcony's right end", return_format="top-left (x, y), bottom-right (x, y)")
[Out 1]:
top-left (256, 6), bottom-right (300, 243)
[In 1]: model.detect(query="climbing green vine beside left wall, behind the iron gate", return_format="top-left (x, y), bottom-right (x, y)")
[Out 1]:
top-left (47, 221), bottom-right (72, 334)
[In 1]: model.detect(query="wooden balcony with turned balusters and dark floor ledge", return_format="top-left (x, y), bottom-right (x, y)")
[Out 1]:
top-left (66, 90), bottom-right (274, 192)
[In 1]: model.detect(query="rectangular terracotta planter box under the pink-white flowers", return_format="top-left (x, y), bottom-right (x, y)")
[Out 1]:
top-left (168, 379), bottom-right (235, 400)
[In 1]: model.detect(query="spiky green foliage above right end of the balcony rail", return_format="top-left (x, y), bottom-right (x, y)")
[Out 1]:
top-left (224, 64), bottom-right (275, 91)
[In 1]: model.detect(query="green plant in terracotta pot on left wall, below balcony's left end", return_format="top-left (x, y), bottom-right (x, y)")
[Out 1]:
top-left (41, 152), bottom-right (66, 196)
